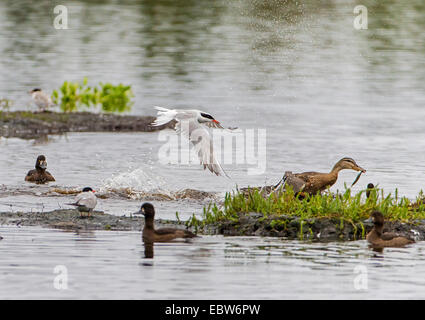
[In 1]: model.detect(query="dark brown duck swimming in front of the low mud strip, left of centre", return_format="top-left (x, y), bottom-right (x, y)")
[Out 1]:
top-left (134, 202), bottom-right (196, 243)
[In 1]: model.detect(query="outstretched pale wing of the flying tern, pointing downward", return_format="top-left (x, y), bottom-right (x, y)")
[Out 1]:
top-left (176, 119), bottom-right (229, 178)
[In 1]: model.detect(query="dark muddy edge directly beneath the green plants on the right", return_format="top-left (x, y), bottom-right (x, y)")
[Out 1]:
top-left (201, 213), bottom-right (425, 241)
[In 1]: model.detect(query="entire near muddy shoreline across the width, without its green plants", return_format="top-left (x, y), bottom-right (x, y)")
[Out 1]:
top-left (0, 209), bottom-right (425, 242)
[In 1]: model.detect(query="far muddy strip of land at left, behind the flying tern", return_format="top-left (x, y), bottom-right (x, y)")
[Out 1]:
top-left (0, 111), bottom-right (174, 139)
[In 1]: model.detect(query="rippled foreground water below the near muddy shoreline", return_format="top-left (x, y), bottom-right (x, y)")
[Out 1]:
top-left (0, 227), bottom-right (425, 299)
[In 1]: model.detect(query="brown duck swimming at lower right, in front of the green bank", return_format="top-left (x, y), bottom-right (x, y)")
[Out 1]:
top-left (366, 211), bottom-right (415, 248)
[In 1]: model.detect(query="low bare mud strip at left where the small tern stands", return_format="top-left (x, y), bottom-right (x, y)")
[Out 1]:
top-left (0, 209), bottom-right (189, 231)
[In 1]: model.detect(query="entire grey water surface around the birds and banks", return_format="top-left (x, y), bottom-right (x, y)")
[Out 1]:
top-left (0, 0), bottom-right (425, 299)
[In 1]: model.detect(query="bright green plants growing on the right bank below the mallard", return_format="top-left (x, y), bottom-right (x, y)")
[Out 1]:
top-left (196, 188), bottom-right (425, 228)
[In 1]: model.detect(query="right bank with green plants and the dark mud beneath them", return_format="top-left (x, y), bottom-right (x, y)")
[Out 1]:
top-left (187, 189), bottom-right (425, 240)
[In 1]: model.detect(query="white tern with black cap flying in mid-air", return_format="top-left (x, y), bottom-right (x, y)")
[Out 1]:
top-left (152, 107), bottom-right (229, 177)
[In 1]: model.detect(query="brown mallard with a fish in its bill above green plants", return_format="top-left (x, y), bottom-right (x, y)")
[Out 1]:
top-left (274, 157), bottom-right (366, 194)
